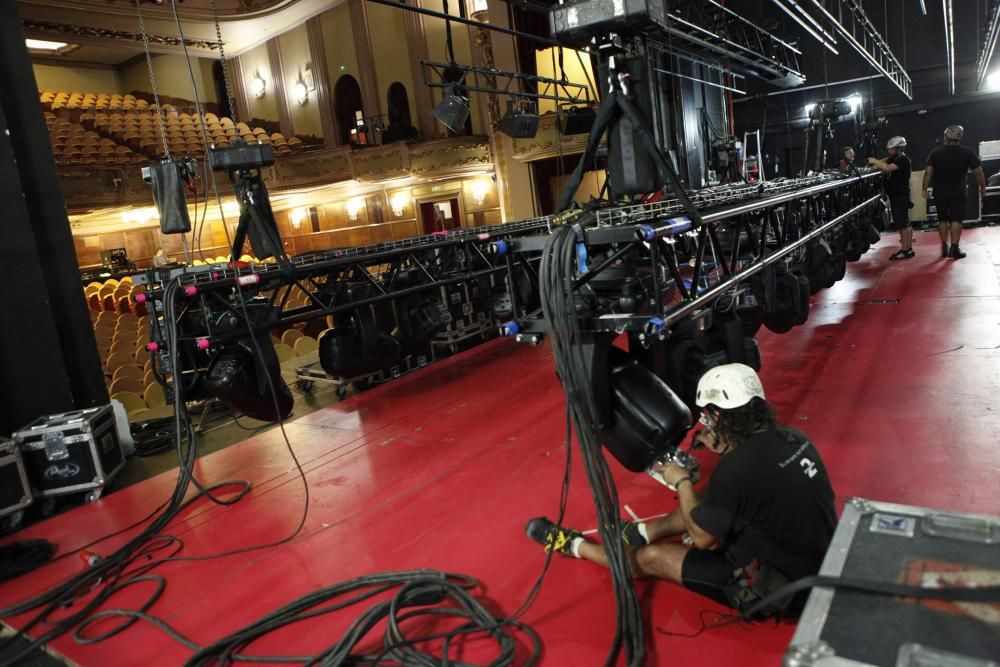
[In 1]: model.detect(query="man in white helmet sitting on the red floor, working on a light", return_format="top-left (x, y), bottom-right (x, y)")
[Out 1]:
top-left (525, 364), bottom-right (837, 614)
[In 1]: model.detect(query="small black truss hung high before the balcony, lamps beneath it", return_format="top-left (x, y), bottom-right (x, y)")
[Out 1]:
top-left (420, 60), bottom-right (592, 104)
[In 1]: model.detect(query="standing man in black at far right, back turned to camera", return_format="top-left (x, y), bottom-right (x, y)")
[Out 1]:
top-left (924, 125), bottom-right (986, 259)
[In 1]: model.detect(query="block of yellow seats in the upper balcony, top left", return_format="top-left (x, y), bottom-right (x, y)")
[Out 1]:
top-left (40, 91), bottom-right (305, 165)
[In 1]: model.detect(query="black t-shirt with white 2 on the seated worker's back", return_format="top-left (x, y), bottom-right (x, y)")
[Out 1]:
top-left (691, 426), bottom-right (837, 580)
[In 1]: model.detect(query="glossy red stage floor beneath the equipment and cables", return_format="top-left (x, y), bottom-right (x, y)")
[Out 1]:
top-left (0, 229), bottom-right (1000, 666)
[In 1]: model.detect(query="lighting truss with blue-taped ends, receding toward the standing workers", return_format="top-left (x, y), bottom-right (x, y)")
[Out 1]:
top-left (494, 173), bottom-right (882, 343)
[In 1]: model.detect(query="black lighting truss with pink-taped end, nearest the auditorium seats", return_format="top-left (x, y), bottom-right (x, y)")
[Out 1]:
top-left (135, 218), bottom-right (549, 358)
